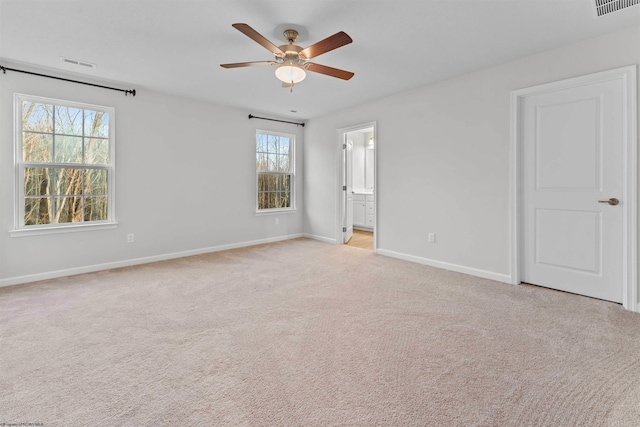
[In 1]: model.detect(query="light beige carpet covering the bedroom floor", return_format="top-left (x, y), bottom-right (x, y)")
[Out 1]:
top-left (0, 239), bottom-right (640, 426)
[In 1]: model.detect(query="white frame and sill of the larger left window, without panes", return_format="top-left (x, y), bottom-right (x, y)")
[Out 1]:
top-left (9, 93), bottom-right (117, 237)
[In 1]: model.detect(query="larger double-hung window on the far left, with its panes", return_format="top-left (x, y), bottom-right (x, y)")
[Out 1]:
top-left (15, 95), bottom-right (114, 234)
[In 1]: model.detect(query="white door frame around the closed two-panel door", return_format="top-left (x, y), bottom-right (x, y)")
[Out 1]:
top-left (509, 65), bottom-right (639, 312)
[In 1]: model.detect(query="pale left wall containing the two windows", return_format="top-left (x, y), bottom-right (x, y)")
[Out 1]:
top-left (0, 61), bottom-right (303, 286)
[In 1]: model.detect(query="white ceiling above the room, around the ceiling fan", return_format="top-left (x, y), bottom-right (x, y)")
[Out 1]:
top-left (0, 0), bottom-right (640, 119)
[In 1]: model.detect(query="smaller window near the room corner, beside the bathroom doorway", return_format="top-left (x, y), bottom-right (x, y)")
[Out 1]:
top-left (256, 131), bottom-right (294, 212)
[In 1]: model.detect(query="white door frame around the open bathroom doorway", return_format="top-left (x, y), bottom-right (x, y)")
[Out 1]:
top-left (336, 121), bottom-right (379, 253)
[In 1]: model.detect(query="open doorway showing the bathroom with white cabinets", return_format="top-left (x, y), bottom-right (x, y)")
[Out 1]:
top-left (337, 122), bottom-right (377, 251)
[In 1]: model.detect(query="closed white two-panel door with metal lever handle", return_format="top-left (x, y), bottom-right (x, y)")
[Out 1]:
top-left (520, 73), bottom-right (627, 302)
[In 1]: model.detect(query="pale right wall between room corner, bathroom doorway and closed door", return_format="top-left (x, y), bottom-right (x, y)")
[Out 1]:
top-left (305, 27), bottom-right (640, 292)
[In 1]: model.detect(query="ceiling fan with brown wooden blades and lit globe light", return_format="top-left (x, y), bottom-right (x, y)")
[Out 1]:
top-left (220, 24), bottom-right (354, 90)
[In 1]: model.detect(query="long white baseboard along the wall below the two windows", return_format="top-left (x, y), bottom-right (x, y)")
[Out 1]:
top-left (0, 233), bottom-right (307, 287)
